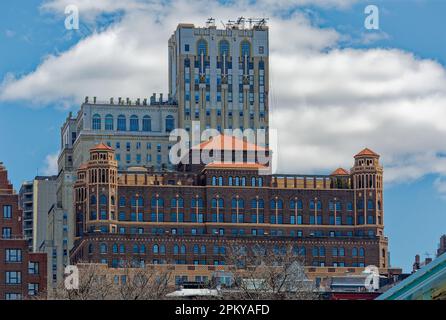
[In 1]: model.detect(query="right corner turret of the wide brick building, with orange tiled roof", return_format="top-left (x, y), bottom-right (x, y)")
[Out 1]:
top-left (351, 148), bottom-right (388, 268)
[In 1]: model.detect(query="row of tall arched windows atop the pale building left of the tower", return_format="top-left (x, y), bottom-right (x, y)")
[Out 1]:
top-left (91, 114), bottom-right (175, 132)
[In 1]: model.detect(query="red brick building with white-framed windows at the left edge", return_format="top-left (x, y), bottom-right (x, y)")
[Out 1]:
top-left (0, 163), bottom-right (46, 300)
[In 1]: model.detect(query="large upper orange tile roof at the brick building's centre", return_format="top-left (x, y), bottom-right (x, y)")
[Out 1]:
top-left (192, 134), bottom-right (268, 151)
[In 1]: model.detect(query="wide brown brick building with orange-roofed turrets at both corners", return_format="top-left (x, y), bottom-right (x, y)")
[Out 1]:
top-left (70, 138), bottom-right (388, 282)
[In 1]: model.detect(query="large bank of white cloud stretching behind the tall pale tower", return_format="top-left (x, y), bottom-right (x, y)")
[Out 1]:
top-left (0, 0), bottom-right (446, 191)
